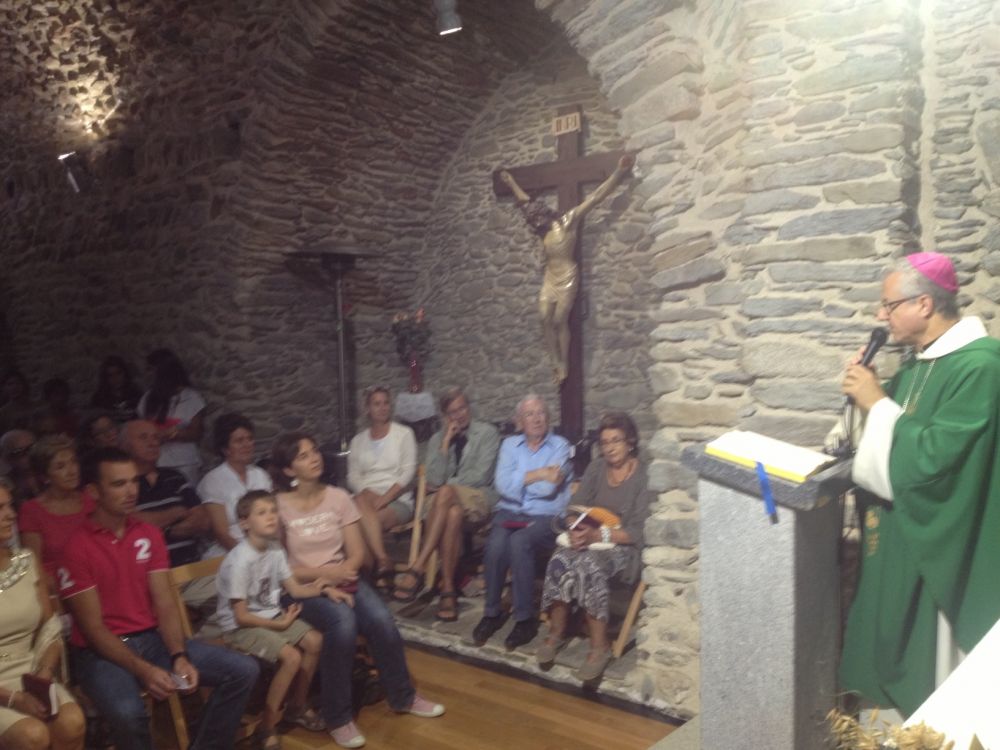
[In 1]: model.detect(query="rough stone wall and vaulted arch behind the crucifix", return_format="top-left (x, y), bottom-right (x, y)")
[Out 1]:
top-left (0, 0), bottom-right (1000, 728)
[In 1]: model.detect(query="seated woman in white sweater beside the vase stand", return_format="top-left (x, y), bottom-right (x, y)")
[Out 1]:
top-left (347, 386), bottom-right (417, 591)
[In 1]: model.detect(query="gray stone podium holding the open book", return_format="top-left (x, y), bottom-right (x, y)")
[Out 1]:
top-left (684, 445), bottom-right (852, 750)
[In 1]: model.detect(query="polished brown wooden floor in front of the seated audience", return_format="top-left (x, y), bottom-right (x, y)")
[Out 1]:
top-left (276, 649), bottom-right (674, 750)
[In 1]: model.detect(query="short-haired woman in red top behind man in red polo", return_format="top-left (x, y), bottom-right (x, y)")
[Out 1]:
top-left (18, 435), bottom-right (94, 593)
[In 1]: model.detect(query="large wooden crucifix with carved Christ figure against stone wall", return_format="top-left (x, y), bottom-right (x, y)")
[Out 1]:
top-left (493, 106), bottom-right (633, 442)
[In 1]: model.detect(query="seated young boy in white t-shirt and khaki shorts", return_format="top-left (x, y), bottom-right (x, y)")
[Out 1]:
top-left (216, 490), bottom-right (351, 750)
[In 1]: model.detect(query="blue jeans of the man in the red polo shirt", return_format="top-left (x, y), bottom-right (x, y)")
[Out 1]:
top-left (73, 631), bottom-right (260, 750)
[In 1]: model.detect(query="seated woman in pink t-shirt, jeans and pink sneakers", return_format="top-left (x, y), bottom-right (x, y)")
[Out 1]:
top-left (271, 433), bottom-right (444, 747)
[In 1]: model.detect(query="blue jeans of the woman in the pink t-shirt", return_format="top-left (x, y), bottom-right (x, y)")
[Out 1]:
top-left (300, 581), bottom-right (416, 729)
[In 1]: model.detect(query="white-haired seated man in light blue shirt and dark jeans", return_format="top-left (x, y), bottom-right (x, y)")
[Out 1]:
top-left (472, 394), bottom-right (573, 651)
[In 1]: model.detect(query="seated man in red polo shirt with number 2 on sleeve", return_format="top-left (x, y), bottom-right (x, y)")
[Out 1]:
top-left (58, 448), bottom-right (259, 750)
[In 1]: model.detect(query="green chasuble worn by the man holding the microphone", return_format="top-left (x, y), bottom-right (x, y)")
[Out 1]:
top-left (840, 334), bottom-right (1000, 715)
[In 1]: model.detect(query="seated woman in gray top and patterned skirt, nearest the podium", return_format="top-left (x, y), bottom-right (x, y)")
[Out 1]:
top-left (537, 412), bottom-right (650, 682)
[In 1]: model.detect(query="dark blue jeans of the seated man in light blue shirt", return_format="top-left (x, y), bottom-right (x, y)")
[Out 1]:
top-left (483, 510), bottom-right (556, 622)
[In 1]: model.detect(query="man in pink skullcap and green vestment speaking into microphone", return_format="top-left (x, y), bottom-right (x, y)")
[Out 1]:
top-left (840, 253), bottom-right (1000, 714)
